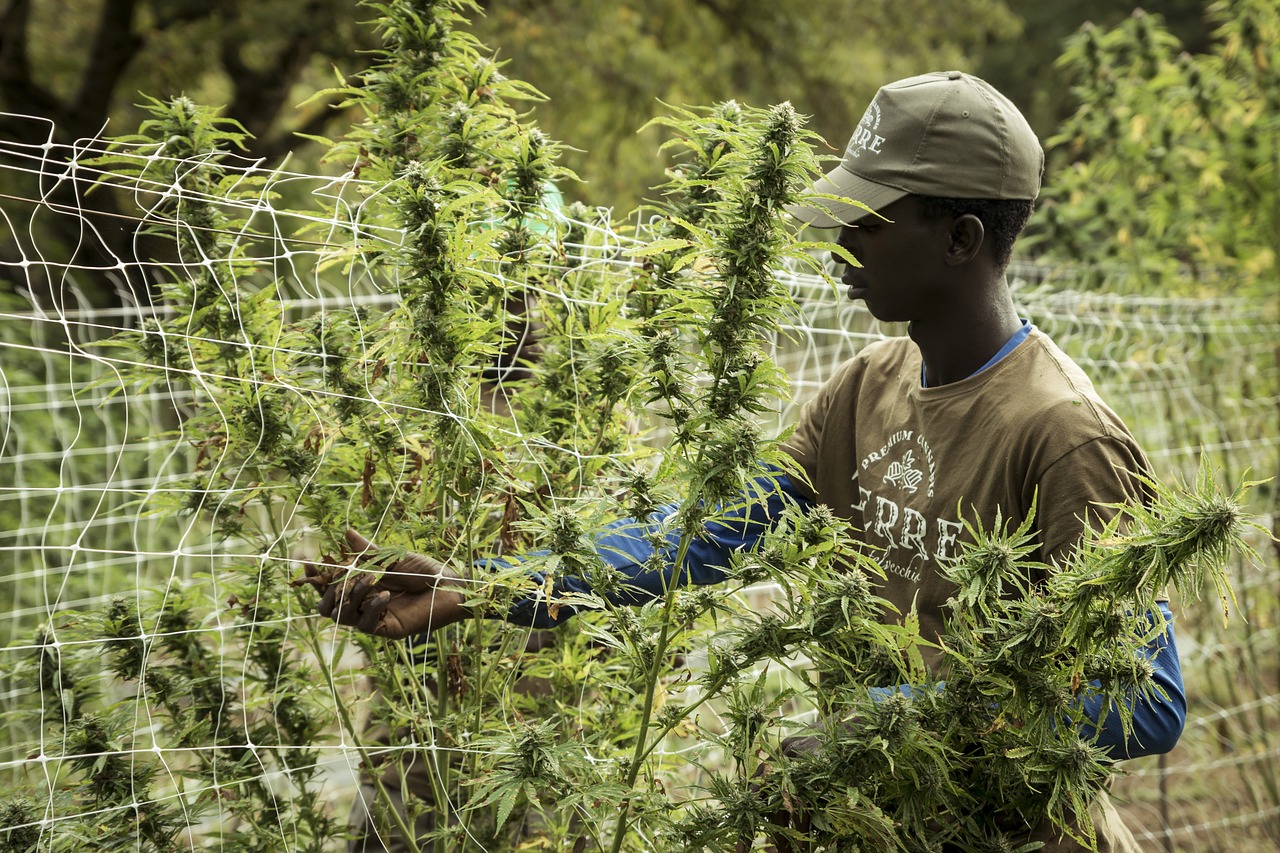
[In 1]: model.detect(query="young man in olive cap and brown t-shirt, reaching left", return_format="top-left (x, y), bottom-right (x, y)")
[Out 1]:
top-left (307, 72), bottom-right (1185, 850)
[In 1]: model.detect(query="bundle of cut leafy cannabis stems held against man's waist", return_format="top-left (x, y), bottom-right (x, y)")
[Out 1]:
top-left (737, 471), bottom-right (1266, 850)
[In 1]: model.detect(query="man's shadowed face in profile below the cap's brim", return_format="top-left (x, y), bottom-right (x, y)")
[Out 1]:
top-left (833, 196), bottom-right (950, 321)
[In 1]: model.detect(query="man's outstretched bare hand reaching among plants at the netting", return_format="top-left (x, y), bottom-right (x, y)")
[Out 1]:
top-left (293, 528), bottom-right (471, 639)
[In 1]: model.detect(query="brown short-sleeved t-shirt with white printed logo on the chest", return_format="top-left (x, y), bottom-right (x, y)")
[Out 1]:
top-left (787, 329), bottom-right (1149, 665)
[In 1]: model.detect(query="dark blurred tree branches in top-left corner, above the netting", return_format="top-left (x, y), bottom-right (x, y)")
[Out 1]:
top-left (0, 0), bottom-right (374, 158)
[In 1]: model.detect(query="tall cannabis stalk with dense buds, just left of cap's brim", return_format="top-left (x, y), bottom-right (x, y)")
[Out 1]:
top-left (612, 104), bottom-right (829, 853)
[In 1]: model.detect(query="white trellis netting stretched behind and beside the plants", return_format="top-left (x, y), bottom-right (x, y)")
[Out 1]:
top-left (0, 119), bottom-right (1280, 852)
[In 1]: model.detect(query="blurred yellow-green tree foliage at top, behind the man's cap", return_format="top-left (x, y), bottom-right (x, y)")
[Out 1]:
top-left (475, 0), bottom-right (1019, 213)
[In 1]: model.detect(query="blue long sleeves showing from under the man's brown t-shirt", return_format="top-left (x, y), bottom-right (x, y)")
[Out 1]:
top-left (492, 473), bottom-right (1187, 758)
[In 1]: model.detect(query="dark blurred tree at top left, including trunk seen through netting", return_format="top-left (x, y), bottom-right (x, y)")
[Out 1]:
top-left (0, 0), bottom-right (374, 306)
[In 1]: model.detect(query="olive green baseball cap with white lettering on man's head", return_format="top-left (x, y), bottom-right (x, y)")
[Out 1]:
top-left (787, 70), bottom-right (1044, 228)
